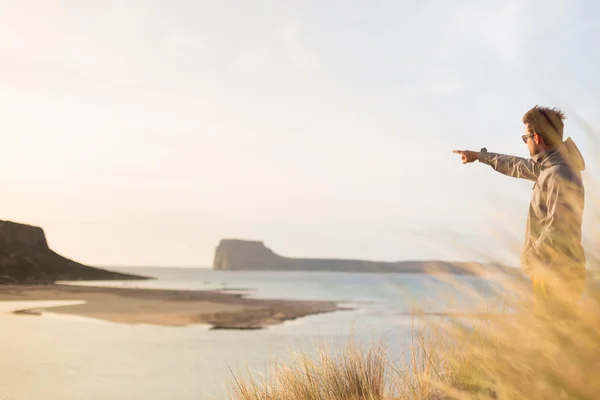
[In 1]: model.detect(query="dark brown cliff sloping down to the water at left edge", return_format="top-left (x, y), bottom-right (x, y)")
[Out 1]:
top-left (0, 220), bottom-right (146, 284)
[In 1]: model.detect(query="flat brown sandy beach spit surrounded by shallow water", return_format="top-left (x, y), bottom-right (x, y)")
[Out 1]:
top-left (0, 285), bottom-right (340, 329)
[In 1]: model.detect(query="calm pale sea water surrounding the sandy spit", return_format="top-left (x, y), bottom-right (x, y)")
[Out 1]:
top-left (0, 268), bottom-right (496, 400)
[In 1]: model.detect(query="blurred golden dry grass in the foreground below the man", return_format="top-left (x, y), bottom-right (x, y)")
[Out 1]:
top-left (231, 281), bottom-right (600, 400)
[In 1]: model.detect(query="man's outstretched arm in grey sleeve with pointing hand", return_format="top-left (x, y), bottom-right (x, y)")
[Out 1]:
top-left (454, 150), bottom-right (542, 181)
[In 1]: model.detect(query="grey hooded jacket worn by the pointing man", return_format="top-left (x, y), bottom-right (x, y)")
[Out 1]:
top-left (479, 138), bottom-right (585, 277)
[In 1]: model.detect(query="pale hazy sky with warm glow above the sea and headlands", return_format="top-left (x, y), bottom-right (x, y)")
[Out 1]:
top-left (0, 0), bottom-right (600, 266)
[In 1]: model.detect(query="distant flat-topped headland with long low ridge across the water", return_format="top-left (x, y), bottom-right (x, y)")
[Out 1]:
top-left (213, 239), bottom-right (490, 275)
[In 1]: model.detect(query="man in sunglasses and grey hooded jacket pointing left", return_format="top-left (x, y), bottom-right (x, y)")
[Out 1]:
top-left (454, 106), bottom-right (586, 308)
